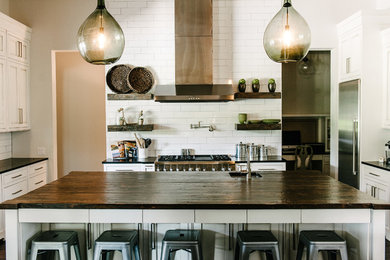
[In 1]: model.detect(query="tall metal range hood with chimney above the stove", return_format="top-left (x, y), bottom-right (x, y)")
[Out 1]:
top-left (155, 0), bottom-right (234, 102)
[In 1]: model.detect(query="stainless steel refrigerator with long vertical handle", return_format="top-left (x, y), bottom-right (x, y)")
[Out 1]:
top-left (338, 80), bottom-right (360, 189)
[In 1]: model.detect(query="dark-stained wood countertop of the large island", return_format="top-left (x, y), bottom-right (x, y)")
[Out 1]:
top-left (0, 171), bottom-right (390, 209)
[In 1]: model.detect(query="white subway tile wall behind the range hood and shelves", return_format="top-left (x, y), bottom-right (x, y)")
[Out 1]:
top-left (106, 0), bottom-right (281, 157)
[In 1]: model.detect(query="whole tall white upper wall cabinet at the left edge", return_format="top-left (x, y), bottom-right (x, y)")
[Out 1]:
top-left (0, 13), bottom-right (31, 132)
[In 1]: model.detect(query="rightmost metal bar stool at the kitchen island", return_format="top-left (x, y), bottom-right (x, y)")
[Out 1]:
top-left (297, 230), bottom-right (348, 260)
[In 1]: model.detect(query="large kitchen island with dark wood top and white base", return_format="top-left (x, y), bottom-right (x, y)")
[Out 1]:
top-left (0, 171), bottom-right (390, 260)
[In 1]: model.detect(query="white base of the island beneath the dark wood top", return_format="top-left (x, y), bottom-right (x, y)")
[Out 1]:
top-left (5, 208), bottom-right (385, 260)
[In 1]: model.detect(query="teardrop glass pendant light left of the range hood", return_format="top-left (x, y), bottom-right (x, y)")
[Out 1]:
top-left (77, 0), bottom-right (125, 65)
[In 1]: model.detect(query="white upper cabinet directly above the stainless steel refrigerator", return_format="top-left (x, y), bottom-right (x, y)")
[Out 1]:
top-left (337, 12), bottom-right (362, 82)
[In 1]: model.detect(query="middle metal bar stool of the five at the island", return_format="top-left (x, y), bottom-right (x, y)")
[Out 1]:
top-left (161, 230), bottom-right (203, 260)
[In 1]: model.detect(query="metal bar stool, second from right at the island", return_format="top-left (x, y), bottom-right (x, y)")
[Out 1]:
top-left (234, 230), bottom-right (280, 260)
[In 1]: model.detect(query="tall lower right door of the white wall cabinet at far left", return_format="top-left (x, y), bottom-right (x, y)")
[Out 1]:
top-left (7, 61), bottom-right (30, 131)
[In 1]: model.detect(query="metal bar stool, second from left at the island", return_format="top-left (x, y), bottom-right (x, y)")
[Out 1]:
top-left (93, 230), bottom-right (141, 260)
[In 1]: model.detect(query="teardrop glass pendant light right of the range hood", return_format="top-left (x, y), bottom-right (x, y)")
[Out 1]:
top-left (263, 0), bottom-right (311, 63)
